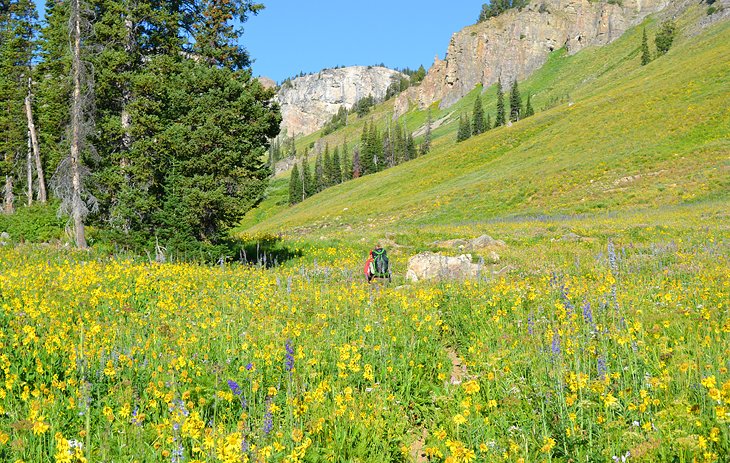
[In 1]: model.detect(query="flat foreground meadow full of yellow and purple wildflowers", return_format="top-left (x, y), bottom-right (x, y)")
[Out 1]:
top-left (0, 216), bottom-right (730, 463)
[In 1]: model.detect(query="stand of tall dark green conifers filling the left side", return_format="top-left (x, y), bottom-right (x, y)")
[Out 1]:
top-left (0, 0), bottom-right (281, 258)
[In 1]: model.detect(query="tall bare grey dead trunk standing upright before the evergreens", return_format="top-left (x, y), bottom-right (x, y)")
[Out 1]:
top-left (69, 0), bottom-right (87, 249)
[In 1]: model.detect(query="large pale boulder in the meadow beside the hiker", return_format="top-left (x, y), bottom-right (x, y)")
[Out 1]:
top-left (406, 252), bottom-right (482, 282)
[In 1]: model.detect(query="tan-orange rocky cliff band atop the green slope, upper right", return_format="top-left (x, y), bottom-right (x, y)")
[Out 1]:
top-left (395, 0), bottom-right (669, 115)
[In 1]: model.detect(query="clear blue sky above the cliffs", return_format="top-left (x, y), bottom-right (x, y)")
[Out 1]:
top-left (37, 0), bottom-right (486, 82)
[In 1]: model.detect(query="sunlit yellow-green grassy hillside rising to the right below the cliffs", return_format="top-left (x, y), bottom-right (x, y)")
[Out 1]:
top-left (241, 11), bottom-right (730, 237)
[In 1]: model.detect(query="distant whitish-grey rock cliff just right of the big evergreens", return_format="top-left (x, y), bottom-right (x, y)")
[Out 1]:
top-left (277, 66), bottom-right (402, 136)
